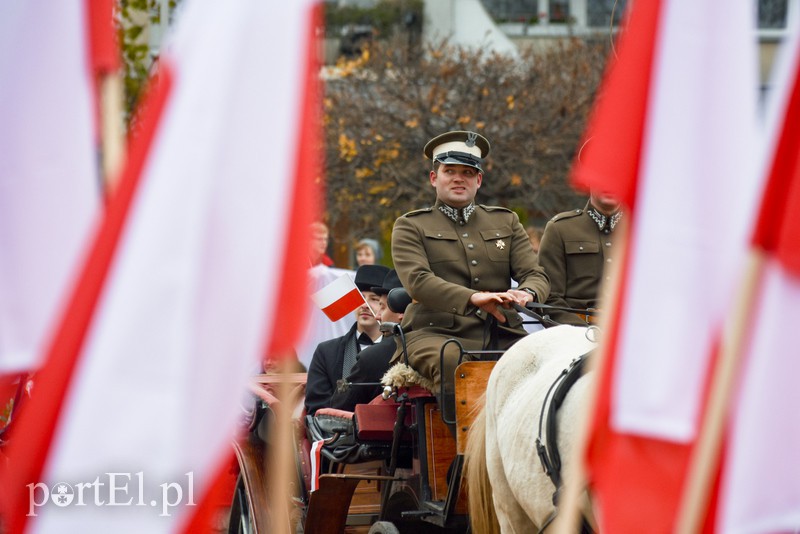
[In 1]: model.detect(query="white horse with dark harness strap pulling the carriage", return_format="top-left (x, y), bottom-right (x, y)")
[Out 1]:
top-left (465, 325), bottom-right (596, 534)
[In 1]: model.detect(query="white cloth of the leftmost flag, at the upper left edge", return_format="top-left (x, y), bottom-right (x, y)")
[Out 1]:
top-left (0, 0), bottom-right (100, 373)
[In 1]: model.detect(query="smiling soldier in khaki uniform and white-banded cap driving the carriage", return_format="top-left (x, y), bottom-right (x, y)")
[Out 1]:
top-left (392, 131), bottom-right (549, 414)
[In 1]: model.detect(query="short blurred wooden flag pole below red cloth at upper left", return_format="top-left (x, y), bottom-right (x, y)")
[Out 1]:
top-left (99, 71), bottom-right (125, 189)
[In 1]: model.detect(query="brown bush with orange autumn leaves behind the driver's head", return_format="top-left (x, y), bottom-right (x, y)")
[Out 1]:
top-left (324, 37), bottom-right (607, 266)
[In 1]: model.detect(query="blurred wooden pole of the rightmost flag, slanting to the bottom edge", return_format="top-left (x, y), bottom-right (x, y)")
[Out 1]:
top-left (676, 249), bottom-right (765, 534)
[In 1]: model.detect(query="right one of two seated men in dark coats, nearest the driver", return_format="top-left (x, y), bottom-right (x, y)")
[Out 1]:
top-left (330, 269), bottom-right (410, 411)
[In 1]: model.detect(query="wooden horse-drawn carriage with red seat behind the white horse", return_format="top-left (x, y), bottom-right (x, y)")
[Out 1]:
top-left (229, 308), bottom-right (596, 534)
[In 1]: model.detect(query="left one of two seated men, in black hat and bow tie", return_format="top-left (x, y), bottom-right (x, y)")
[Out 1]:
top-left (306, 265), bottom-right (389, 415)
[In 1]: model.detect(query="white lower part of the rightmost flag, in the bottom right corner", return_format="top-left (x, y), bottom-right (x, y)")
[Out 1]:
top-left (719, 258), bottom-right (800, 534)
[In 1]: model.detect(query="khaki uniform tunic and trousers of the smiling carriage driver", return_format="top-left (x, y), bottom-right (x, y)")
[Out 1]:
top-left (392, 201), bottom-right (549, 393)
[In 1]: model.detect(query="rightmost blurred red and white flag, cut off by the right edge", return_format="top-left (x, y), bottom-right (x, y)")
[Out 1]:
top-left (716, 33), bottom-right (800, 533)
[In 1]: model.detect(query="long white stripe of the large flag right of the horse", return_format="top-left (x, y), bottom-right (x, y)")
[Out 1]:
top-left (612, 0), bottom-right (759, 442)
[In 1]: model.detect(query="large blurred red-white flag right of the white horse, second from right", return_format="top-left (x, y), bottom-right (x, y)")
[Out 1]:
top-left (575, 0), bottom-right (759, 532)
